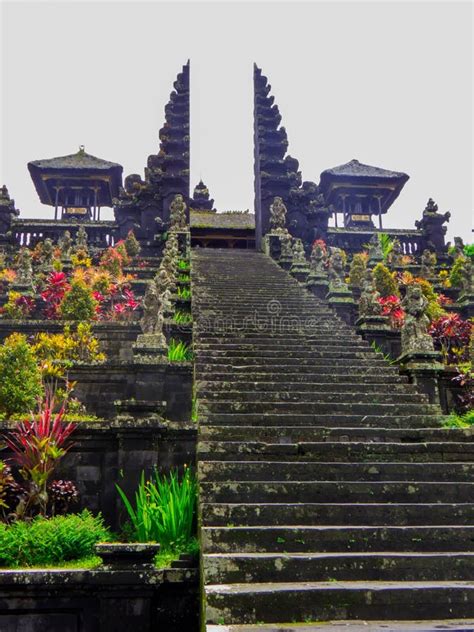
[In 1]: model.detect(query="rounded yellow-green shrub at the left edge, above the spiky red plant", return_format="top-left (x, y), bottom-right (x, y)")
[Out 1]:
top-left (0, 333), bottom-right (42, 416)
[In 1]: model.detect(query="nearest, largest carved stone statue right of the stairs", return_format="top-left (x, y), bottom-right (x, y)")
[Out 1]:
top-left (401, 283), bottom-right (434, 354)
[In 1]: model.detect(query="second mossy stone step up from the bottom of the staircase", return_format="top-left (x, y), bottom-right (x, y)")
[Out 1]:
top-left (203, 551), bottom-right (474, 584)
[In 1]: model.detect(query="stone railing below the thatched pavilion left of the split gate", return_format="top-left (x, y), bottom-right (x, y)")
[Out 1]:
top-left (12, 219), bottom-right (117, 248)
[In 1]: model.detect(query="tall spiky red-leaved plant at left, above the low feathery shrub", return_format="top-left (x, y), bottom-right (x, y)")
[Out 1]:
top-left (4, 396), bottom-right (76, 516)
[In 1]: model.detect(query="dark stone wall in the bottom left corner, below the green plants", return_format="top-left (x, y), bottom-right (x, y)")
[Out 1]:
top-left (0, 568), bottom-right (199, 632)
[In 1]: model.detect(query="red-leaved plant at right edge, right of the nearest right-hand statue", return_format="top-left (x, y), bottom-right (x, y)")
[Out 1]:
top-left (429, 313), bottom-right (472, 364)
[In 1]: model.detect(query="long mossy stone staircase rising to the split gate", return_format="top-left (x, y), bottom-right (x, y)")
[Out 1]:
top-left (192, 250), bottom-right (474, 632)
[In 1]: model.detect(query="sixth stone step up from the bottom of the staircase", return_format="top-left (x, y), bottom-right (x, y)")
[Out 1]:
top-left (198, 461), bottom-right (474, 484)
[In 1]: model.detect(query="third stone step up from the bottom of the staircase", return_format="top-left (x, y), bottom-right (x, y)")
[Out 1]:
top-left (201, 524), bottom-right (474, 552)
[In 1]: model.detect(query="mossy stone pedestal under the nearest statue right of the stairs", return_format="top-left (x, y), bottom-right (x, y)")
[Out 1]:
top-left (398, 351), bottom-right (444, 404)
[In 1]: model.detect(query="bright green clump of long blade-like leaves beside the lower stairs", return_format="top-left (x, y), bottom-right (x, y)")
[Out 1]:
top-left (116, 468), bottom-right (197, 551)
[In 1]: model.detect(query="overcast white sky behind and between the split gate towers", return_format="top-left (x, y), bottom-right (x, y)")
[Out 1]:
top-left (1, 0), bottom-right (473, 241)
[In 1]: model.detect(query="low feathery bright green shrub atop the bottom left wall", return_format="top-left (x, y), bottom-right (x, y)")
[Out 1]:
top-left (0, 510), bottom-right (111, 567)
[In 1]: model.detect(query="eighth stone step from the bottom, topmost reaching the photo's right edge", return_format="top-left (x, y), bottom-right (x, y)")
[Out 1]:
top-left (199, 424), bottom-right (458, 443)
